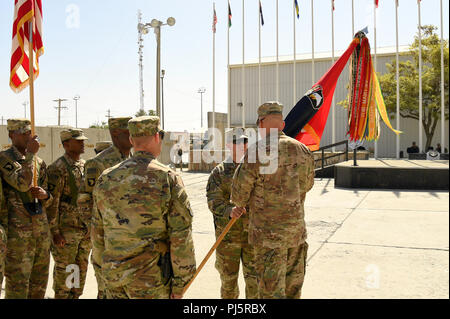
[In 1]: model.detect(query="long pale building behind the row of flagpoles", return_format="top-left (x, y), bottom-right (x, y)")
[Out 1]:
top-left (230, 46), bottom-right (449, 158)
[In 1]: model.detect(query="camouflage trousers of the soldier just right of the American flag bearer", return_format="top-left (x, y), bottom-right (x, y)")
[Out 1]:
top-left (52, 229), bottom-right (91, 299)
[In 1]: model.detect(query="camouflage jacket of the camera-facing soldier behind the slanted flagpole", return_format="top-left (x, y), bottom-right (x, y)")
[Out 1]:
top-left (206, 159), bottom-right (248, 244)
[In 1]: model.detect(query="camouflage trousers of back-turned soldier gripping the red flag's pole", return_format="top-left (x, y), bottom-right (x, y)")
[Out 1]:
top-left (255, 242), bottom-right (308, 299)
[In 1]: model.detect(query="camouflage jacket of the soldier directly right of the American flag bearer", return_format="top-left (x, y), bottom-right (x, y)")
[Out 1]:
top-left (47, 154), bottom-right (85, 235)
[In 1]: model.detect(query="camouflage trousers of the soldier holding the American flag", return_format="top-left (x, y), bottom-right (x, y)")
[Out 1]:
top-left (5, 226), bottom-right (50, 299)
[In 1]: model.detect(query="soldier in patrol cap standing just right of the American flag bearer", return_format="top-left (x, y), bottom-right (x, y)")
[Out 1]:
top-left (47, 129), bottom-right (91, 299)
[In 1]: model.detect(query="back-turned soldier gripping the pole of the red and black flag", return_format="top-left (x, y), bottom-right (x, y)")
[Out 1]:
top-left (231, 102), bottom-right (314, 299)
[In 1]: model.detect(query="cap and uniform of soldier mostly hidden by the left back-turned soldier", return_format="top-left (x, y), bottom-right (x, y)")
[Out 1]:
top-left (78, 117), bottom-right (131, 299)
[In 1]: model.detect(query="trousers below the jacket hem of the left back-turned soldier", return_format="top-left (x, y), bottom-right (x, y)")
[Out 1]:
top-left (105, 275), bottom-right (171, 299)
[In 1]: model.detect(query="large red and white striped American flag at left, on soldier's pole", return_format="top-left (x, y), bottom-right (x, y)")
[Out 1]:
top-left (9, 0), bottom-right (44, 92)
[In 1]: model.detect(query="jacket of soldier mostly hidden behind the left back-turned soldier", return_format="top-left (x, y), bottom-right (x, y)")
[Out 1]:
top-left (78, 145), bottom-right (127, 215)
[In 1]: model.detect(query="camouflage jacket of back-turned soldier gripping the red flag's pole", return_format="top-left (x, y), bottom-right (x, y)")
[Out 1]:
top-left (231, 132), bottom-right (314, 248)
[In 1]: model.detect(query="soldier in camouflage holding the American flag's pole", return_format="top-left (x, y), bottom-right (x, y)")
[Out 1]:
top-left (1, 119), bottom-right (52, 299)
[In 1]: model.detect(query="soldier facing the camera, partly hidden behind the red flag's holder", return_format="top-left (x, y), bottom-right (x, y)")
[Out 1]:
top-left (206, 129), bottom-right (258, 299)
